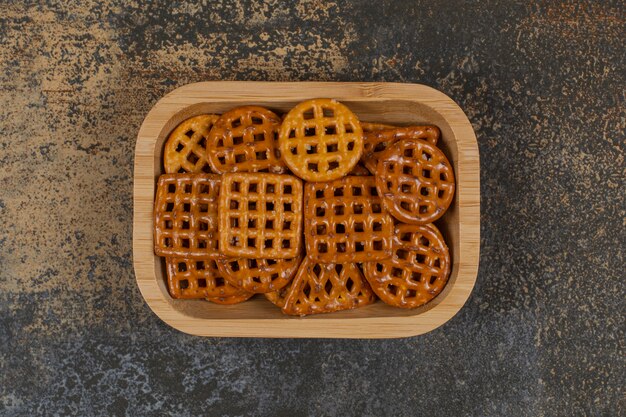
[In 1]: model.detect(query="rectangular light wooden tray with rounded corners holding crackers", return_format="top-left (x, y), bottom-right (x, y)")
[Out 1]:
top-left (133, 81), bottom-right (480, 338)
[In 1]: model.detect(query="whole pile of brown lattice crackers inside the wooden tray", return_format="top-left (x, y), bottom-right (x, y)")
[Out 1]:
top-left (154, 99), bottom-right (455, 316)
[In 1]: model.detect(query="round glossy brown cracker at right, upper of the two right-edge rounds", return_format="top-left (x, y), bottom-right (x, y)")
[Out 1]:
top-left (376, 139), bottom-right (455, 224)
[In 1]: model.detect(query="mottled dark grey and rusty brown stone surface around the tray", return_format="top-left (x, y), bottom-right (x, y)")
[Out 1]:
top-left (0, 0), bottom-right (626, 416)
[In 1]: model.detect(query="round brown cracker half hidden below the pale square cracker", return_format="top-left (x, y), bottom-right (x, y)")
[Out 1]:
top-left (217, 256), bottom-right (302, 293)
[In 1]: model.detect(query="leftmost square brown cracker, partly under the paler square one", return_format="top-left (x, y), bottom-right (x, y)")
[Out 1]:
top-left (154, 174), bottom-right (221, 259)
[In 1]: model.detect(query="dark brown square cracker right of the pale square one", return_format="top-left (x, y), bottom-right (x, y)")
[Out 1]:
top-left (304, 176), bottom-right (393, 262)
